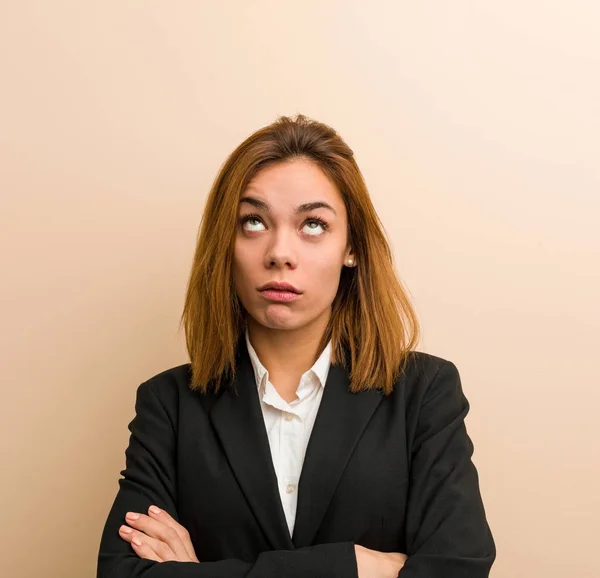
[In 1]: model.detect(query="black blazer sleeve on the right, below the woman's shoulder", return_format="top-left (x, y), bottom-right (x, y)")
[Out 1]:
top-left (399, 360), bottom-right (496, 578)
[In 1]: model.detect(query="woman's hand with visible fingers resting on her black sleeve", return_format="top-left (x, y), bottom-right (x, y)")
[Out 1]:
top-left (119, 506), bottom-right (199, 562)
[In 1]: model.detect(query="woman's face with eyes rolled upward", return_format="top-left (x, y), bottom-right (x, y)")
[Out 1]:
top-left (233, 159), bottom-right (353, 330)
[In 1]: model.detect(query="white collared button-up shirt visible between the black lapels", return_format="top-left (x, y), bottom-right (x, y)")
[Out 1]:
top-left (246, 329), bottom-right (332, 537)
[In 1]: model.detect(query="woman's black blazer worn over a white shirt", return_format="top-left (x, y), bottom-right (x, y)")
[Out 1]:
top-left (97, 339), bottom-right (496, 578)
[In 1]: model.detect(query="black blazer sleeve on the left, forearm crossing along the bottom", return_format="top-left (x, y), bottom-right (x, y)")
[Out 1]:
top-left (96, 382), bottom-right (358, 578)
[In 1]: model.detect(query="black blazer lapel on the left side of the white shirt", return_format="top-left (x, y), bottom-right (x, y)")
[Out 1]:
top-left (210, 338), bottom-right (294, 550)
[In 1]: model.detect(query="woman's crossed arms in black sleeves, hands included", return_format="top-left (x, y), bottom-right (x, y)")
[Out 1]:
top-left (97, 362), bottom-right (496, 578)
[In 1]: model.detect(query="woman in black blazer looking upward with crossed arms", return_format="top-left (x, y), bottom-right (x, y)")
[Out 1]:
top-left (98, 115), bottom-right (496, 578)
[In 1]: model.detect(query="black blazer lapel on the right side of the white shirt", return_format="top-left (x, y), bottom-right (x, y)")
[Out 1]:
top-left (292, 365), bottom-right (383, 548)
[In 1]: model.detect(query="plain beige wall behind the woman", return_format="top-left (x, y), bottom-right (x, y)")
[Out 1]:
top-left (0, 0), bottom-right (600, 578)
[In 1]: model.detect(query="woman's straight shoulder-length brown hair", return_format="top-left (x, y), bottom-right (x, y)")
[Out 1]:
top-left (181, 114), bottom-right (419, 394)
